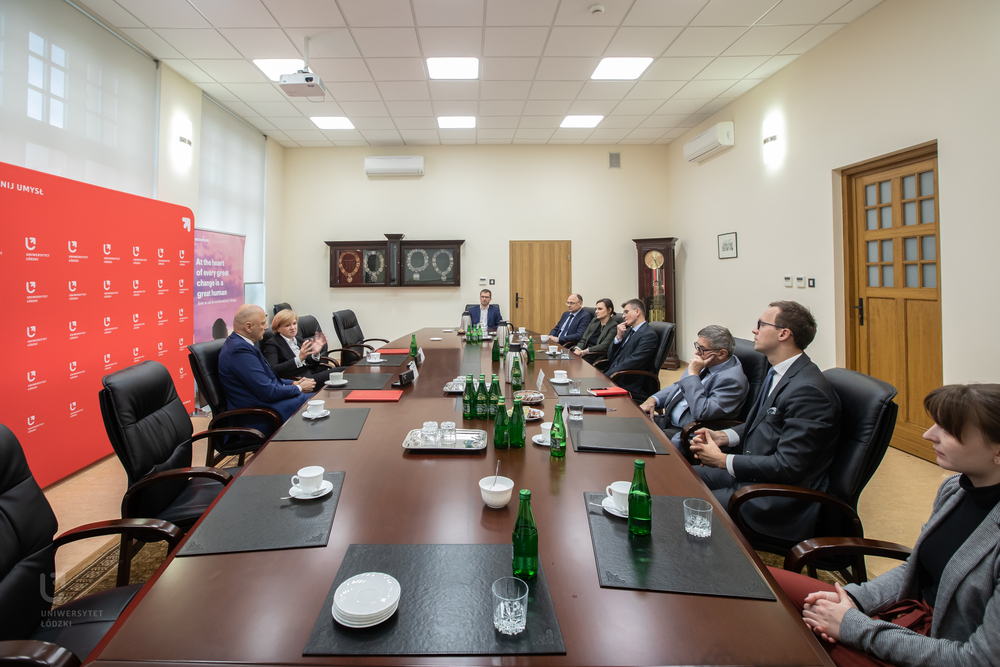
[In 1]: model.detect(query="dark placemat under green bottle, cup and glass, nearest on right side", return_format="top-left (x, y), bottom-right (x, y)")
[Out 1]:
top-left (583, 493), bottom-right (775, 600)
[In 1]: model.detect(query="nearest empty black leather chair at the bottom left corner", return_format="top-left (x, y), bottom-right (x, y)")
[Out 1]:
top-left (0, 425), bottom-right (183, 667)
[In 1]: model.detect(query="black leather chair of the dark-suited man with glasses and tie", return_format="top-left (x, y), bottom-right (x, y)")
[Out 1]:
top-left (729, 368), bottom-right (898, 577)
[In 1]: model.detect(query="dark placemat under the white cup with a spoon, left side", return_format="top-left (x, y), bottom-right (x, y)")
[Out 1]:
top-left (177, 472), bottom-right (345, 556)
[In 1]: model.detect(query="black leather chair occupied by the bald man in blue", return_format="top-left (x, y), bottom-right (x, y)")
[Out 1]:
top-left (188, 334), bottom-right (283, 466)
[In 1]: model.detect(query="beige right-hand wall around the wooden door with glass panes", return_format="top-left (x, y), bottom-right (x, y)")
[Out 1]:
top-left (666, 0), bottom-right (1000, 382)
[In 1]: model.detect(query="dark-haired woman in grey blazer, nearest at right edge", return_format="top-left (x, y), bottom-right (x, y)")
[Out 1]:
top-left (771, 384), bottom-right (1000, 667)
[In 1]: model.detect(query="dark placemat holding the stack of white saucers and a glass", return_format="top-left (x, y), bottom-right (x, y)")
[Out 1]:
top-left (302, 544), bottom-right (566, 656)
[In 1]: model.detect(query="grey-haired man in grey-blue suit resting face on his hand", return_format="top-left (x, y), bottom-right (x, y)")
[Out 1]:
top-left (639, 324), bottom-right (749, 447)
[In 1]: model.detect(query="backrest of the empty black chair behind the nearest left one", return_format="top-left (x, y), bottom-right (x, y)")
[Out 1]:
top-left (99, 362), bottom-right (195, 517)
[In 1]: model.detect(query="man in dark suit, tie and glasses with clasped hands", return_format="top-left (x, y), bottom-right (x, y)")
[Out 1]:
top-left (691, 301), bottom-right (840, 542)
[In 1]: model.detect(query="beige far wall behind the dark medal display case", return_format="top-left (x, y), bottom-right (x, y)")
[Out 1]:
top-left (282, 146), bottom-right (668, 339)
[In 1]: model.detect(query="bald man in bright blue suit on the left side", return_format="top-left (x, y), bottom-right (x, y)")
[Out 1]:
top-left (219, 303), bottom-right (316, 435)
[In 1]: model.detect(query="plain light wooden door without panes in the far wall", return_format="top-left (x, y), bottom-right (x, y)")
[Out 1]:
top-left (507, 241), bottom-right (573, 333)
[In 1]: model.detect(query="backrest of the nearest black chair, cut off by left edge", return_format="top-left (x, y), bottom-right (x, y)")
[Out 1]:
top-left (0, 424), bottom-right (57, 641)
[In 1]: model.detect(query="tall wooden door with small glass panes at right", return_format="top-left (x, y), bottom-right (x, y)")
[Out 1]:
top-left (844, 144), bottom-right (943, 461)
